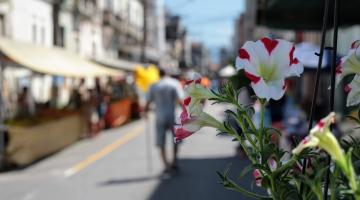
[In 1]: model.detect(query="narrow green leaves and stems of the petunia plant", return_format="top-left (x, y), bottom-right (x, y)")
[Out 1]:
top-left (210, 80), bottom-right (360, 200)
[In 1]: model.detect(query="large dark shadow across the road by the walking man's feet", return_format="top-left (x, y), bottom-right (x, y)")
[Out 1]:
top-left (148, 157), bottom-right (266, 200)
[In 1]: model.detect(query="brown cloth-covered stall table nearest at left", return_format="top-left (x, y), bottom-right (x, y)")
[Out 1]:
top-left (6, 113), bottom-right (85, 166)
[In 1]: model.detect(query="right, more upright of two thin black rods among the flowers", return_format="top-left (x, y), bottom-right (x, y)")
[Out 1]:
top-left (323, 0), bottom-right (339, 200)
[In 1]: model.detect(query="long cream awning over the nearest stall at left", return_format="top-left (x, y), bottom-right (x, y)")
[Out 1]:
top-left (0, 38), bottom-right (123, 77)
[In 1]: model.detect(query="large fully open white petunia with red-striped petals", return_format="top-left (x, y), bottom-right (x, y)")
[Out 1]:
top-left (236, 38), bottom-right (304, 100)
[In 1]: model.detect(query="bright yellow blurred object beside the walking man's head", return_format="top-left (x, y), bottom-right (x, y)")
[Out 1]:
top-left (135, 65), bottom-right (160, 92)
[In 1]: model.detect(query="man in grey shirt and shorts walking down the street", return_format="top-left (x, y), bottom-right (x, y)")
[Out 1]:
top-left (145, 69), bottom-right (184, 174)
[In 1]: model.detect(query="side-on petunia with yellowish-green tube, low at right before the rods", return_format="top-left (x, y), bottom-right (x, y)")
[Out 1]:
top-left (292, 112), bottom-right (345, 165)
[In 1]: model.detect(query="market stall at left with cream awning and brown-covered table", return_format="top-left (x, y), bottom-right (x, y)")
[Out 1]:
top-left (0, 38), bottom-right (124, 166)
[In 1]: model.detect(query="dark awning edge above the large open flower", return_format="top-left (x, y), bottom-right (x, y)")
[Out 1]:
top-left (257, 0), bottom-right (360, 30)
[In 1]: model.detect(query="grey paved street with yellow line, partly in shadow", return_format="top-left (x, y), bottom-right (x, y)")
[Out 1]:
top-left (0, 104), bottom-right (264, 200)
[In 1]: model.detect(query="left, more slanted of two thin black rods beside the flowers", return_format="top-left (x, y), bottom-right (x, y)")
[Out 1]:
top-left (300, 0), bottom-right (330, 195)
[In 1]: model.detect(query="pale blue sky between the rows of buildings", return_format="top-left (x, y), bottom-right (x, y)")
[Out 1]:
top-left (164, 0), bottom-right (244, 61)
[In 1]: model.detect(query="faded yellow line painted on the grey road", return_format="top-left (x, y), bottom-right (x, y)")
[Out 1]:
top-left (64, 127), bottom-right (143, 177)
